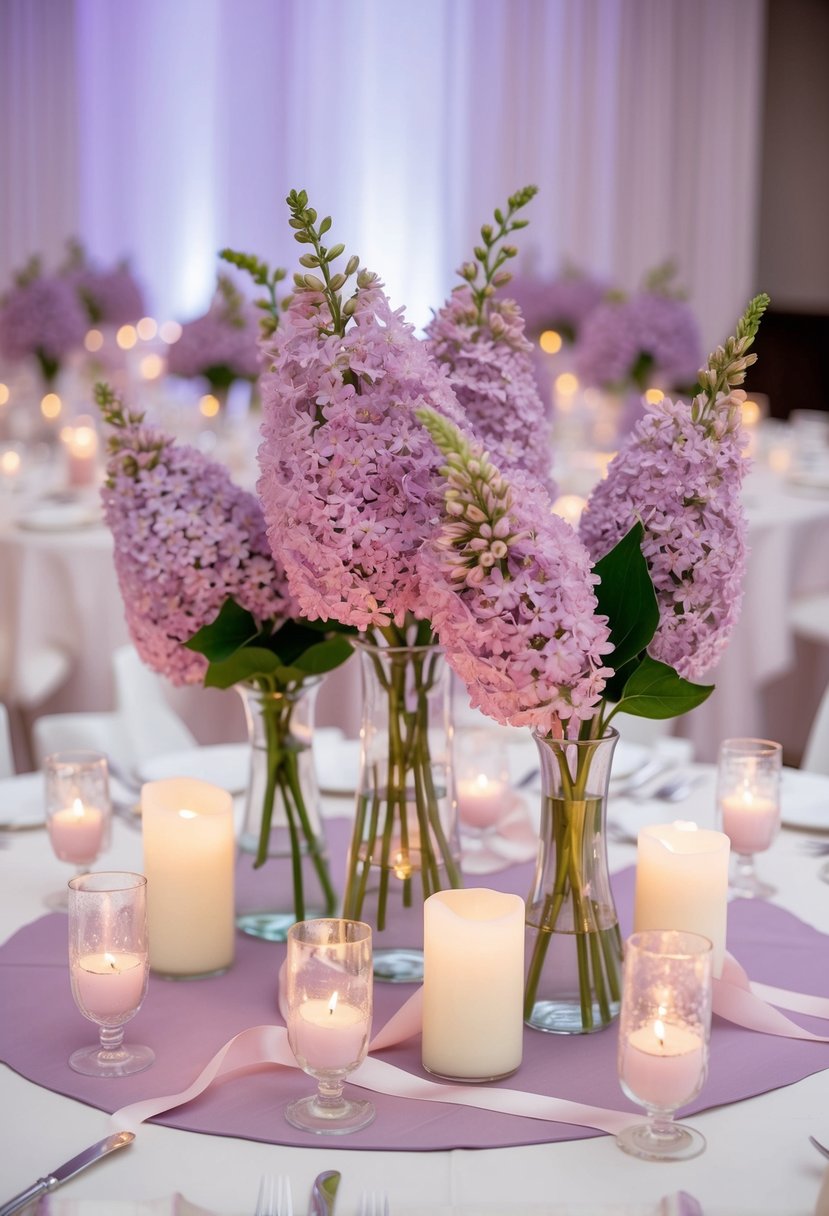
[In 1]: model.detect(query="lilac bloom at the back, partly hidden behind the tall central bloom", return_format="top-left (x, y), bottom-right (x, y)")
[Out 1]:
top-left (427, 285), bottom-right (552, 482)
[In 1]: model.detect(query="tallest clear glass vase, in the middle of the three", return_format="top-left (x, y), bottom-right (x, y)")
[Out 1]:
top-left (343, 640), bottom-right (462, 983)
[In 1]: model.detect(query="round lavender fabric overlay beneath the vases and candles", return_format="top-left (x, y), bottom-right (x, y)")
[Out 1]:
top-left (0, 821), bottom-right (829, 1150)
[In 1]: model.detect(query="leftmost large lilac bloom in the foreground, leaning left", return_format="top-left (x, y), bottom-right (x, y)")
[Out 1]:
top-left (102, 401), bottom-right (295, 685)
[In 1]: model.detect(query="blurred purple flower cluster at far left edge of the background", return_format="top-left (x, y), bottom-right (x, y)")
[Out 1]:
top-left (0, 264), bottom-right (88, 375)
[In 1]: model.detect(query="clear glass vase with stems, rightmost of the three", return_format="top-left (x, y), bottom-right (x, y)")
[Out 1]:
top-left (524, 730), bottom-right (622, 1035)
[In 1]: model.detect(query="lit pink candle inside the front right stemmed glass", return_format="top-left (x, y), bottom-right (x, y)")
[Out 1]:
top-left (620, 1018), bottom-right (705, 1110)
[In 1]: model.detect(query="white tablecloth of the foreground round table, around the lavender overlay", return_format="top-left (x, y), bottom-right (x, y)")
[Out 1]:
top-left (0, 766), bottom-right (829, 1216)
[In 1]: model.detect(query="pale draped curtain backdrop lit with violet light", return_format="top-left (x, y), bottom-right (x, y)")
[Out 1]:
top-left (0, 0), bottom-right (765, 344)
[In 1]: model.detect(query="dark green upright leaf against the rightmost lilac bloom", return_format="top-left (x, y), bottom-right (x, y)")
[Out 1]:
top-left (593, 523), bottom-right (659, 670)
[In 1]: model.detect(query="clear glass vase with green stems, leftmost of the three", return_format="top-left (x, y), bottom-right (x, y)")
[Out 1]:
top-left (236, 679), bottom-right (337, 941)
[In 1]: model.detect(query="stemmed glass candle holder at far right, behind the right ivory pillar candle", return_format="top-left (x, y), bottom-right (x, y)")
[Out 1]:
top-left (717, 739), bottom-right (783, 899)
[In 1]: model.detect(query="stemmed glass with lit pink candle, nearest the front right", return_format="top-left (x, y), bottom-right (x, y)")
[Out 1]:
top-left (616, 929), bottom-right (711, 1161)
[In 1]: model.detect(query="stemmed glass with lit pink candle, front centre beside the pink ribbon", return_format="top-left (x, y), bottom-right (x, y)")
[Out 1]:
top-left (284, 918), bottom-right (374, 1135)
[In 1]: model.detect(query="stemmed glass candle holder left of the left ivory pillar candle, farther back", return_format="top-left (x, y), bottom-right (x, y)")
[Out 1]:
top-left (44, 751), bottom-right (112, 911)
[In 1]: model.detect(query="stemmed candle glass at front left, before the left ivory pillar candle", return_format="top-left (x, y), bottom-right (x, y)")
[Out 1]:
top-left (69, 872), bottom-right (156, 1076)
